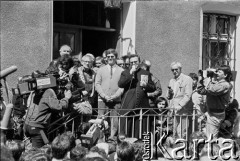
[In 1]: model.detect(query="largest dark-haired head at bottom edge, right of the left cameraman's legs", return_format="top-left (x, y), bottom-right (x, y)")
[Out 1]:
top-left (52, 135), bottom-right (71, 159)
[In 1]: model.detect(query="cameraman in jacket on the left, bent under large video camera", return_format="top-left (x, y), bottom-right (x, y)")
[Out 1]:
top-left (24, 83), bottom-right (72, 148)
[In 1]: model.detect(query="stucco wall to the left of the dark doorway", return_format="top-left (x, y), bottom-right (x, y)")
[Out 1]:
top-left (1, 1), bottom-right (53, 93)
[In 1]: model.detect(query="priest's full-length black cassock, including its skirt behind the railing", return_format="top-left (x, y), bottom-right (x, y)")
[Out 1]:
top-left (118, 68), bottom-right (156, 138)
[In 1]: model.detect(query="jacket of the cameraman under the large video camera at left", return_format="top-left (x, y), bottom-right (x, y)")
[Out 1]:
top-left (25, 89), bottom-right (68, 128)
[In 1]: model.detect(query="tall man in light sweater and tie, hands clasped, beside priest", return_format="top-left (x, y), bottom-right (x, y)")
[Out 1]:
top-left (95, 49), bottom-right (123, 138)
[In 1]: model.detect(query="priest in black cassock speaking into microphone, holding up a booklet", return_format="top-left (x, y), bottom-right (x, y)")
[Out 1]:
top-left (118, 55), bottom-right (156, 138)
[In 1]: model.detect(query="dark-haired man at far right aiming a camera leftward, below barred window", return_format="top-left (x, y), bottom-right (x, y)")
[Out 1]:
top-left (198, 65), bottom-right (232, 138)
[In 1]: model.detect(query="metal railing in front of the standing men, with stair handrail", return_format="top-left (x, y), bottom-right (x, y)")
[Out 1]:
top-left (48, 108), bottom-right (201, 143)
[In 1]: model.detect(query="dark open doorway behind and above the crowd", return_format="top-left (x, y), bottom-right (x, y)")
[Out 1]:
top-left (53, 1), bottom-right (121, 59)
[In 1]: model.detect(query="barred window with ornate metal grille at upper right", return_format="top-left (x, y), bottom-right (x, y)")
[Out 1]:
top-left (202, 13), bottom-right (236, 69)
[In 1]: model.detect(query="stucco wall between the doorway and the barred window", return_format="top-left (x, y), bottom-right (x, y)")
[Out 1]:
top-left (136, 1), bottom-right (200, 96)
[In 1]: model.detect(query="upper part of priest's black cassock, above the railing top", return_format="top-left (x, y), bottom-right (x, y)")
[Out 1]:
top-left (118, 68), bottom-right (156, 109)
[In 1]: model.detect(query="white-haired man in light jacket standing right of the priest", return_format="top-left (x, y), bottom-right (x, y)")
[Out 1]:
top-left (168, 62), bottom-right (193, 138)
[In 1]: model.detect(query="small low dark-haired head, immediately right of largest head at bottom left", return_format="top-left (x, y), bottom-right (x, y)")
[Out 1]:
top-left (70, 145), bottom-right (88, 161)
